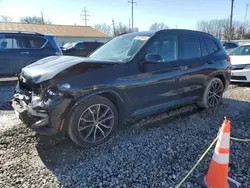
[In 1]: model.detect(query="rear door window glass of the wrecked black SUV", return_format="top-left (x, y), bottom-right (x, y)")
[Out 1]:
top-left (182, 34), bottom-right (201, 59)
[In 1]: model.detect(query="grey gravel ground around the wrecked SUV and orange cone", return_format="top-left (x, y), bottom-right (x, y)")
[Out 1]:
top-left (0, 85), bottom-right (250, 188)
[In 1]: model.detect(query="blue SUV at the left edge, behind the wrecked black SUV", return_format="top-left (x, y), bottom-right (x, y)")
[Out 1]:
top-left (0, 32), bottom-right (62, 76)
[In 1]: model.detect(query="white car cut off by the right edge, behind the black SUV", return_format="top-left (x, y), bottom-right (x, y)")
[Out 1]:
top-left (229, 44), bottom-right (250, 82)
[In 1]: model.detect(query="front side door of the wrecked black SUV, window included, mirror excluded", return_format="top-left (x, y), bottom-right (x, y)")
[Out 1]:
top-left (127, 34), bottom-right (182, 114)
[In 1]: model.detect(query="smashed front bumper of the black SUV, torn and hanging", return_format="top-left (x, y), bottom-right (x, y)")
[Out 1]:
top-left (11, 83), bottom-right (72, 135)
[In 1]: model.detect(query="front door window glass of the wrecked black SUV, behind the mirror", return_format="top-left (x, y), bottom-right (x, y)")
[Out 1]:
top-left (147, 35), bottom-right (178, 62)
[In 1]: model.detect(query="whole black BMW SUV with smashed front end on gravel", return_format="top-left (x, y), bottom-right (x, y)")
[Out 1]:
top-left (12, 29), bottom-right (231, 147)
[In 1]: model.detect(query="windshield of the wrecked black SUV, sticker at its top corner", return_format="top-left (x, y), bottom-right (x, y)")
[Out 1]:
top-left (90, 34), bottom-right (149, 61)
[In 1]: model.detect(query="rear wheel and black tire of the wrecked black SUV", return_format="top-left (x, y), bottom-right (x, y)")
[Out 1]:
top-left (198, 78), bottom-right (224, 109)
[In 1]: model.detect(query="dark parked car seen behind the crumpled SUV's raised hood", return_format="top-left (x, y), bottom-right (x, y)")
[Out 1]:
top-left (62, 42), bottom-right (104, 57)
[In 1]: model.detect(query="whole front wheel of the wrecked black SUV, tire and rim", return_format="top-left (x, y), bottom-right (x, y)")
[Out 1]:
top-left (68, 96), bottom-right (118, 147)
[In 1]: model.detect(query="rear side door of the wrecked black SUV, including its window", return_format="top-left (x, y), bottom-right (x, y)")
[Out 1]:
top-left (180, 34), bottom-right (214, 101)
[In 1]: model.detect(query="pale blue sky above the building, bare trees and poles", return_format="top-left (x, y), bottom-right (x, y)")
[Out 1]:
top-left (0, 0), bottom-right (250, 30)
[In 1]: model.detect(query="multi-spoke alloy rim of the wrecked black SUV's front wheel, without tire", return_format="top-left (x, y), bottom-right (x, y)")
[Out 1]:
top-left (78, 104), bottom-right (115, 143)
